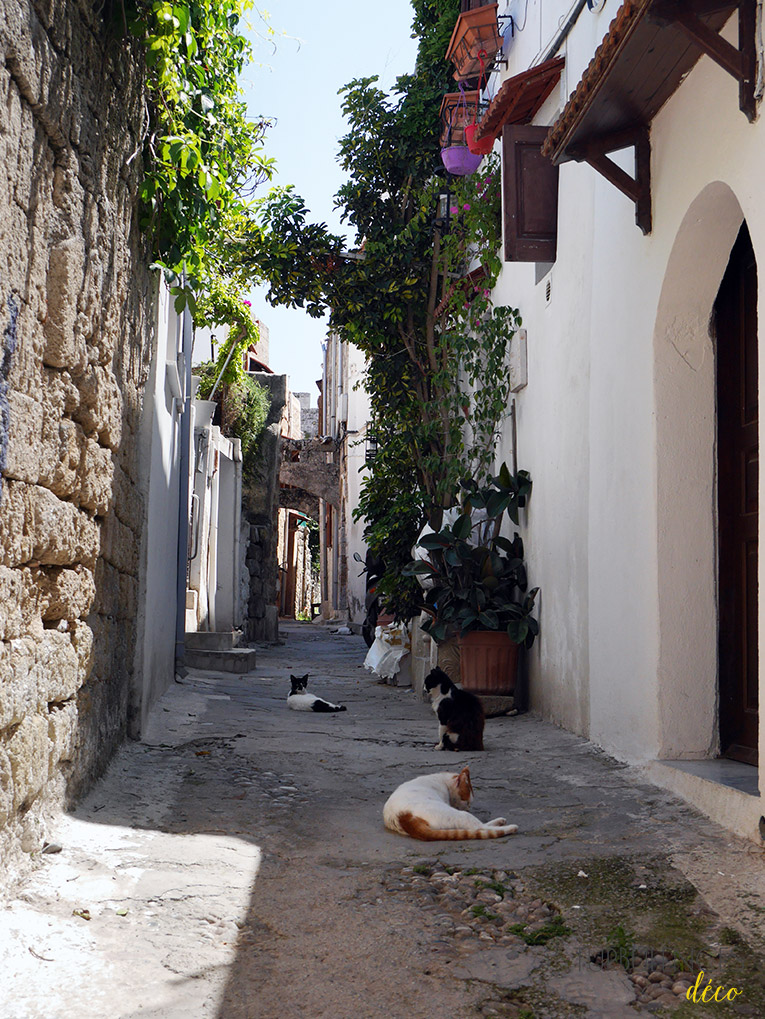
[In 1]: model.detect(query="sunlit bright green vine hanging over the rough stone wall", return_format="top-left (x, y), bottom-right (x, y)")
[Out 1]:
top-left (125, 0), bottom-right (273, 312)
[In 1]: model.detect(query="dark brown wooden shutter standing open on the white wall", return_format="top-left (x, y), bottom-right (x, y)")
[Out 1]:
top-left (502, 124), bottom-right (558, 262)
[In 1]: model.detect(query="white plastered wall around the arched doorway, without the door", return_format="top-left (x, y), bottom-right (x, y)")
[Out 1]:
top-left (495, 5), bottom-right (765, 786)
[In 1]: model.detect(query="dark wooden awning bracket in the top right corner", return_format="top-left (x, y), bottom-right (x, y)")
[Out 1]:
top-left (651, 0), bottom-right (757, 121)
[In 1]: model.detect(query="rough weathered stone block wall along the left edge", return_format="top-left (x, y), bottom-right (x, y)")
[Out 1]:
top-left (0, 0), bottom-right (154, 863)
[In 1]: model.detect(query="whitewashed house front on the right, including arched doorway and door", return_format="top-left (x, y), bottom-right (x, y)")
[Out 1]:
top-left (478, 0), bottom-right (765, 840)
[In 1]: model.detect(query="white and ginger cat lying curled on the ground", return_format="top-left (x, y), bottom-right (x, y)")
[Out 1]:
top-left (383, 767), bottom-right (517, 842)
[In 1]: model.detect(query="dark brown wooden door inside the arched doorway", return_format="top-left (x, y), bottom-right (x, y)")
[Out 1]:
top-left (715, 223), bottom-right (759, 764)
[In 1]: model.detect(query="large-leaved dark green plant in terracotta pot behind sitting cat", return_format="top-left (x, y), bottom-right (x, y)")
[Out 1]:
top-left (406, 464), bottom-right (539, 694)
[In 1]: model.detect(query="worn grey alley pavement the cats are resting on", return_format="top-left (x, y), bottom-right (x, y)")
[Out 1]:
top-left (0, 624), bottom-right (765, 1019)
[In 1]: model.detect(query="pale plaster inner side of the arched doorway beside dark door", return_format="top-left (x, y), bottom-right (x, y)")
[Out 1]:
top-left (654, 181), bottom-right (744, 758)
